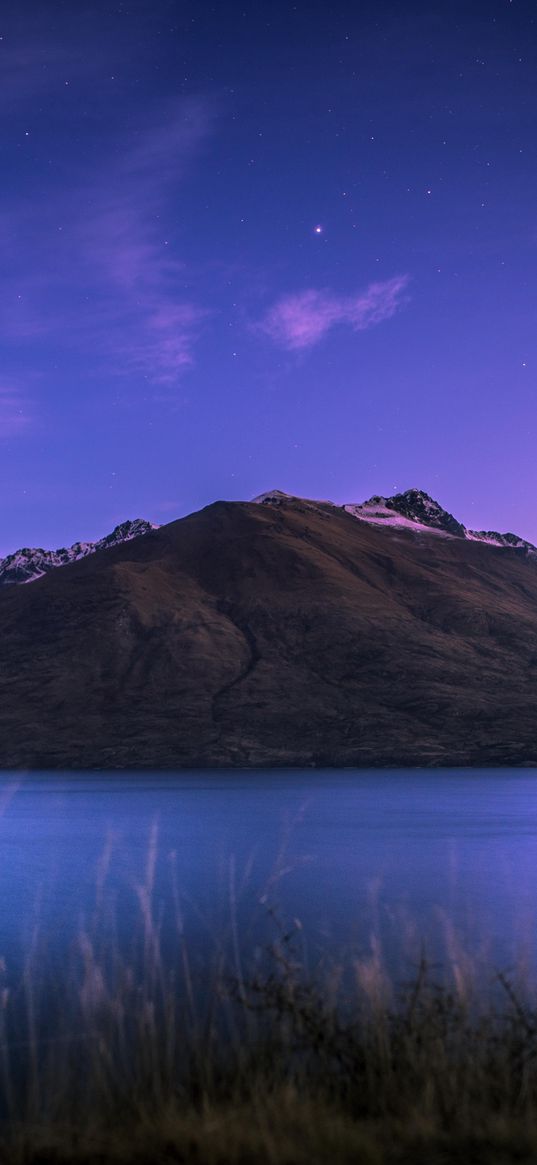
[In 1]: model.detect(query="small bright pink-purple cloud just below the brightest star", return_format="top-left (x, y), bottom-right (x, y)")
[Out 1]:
top-left (259, 275), bottom-right (409, 351)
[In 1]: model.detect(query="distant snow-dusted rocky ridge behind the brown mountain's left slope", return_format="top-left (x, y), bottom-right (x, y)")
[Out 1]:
top-left (0, 517), bottom-right (158, 586)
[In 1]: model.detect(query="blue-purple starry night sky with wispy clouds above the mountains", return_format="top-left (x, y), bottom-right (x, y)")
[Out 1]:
top-left (0, 0), bottom-right (537, 553)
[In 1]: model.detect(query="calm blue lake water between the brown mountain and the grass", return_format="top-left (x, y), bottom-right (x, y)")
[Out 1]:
top-left (0, 770), bottom-right (537, 974)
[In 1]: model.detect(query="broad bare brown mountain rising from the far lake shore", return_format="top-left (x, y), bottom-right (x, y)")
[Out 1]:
top-left (0, 486), bottom-right (537, 769)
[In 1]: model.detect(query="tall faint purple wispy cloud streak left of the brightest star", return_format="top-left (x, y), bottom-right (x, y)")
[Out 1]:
top-left (77, 103), bottom-right (210, 384)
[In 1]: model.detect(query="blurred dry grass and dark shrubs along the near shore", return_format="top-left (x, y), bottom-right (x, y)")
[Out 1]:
top-left (0, 834), bottom-right (537, 1165)
